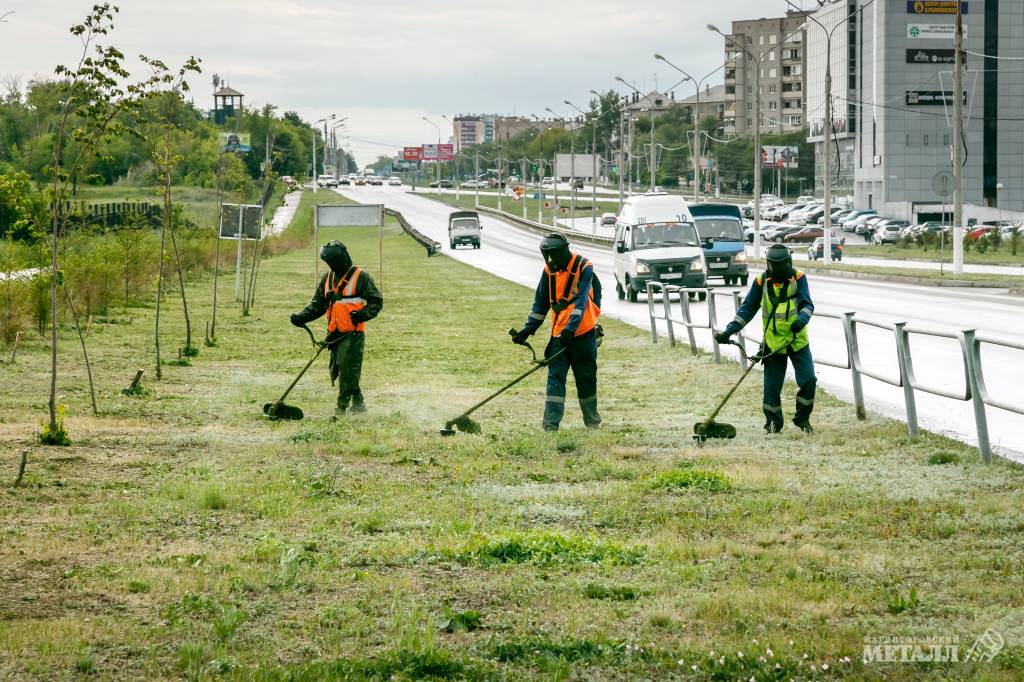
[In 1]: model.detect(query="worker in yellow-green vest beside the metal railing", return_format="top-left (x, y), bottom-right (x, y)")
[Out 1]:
top-left (715, 244), bottom-right (817, 433)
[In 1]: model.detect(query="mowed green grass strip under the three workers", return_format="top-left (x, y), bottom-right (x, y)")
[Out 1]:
top-left (0, 199), bottom-right (1024, 680)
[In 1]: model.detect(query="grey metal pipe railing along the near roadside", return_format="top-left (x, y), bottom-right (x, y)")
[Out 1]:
top-left (647, 282), bottom-right (1024, 462)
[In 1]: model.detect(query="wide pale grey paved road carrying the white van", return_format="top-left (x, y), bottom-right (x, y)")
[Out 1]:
top-left (341, 187), bottom-right (1024, 461)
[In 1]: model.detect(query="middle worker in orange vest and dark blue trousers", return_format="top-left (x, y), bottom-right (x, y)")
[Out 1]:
top-left (512, 235), bottom-right (604, 431)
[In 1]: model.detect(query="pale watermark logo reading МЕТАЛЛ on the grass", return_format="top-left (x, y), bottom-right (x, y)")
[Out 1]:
top-left (862, 629), bottom-right (1006, 664)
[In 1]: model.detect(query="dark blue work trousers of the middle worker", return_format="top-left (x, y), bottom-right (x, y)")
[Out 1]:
top-left (544, 330), bottom-right (601, 431)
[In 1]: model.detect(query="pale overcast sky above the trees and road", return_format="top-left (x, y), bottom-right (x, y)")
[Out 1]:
top-left (0, 0), bottom-right (813, 163)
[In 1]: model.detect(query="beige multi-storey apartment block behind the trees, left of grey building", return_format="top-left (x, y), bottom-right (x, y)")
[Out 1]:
top-left (725, 11), bottom-right (807, 135)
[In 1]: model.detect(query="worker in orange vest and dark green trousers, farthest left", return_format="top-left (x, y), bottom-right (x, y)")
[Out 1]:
top-left (291, 241), bottom-right (384, 416)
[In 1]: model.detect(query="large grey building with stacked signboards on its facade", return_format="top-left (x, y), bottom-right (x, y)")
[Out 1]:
top-left (808, 0), bottom-right (1024, 221)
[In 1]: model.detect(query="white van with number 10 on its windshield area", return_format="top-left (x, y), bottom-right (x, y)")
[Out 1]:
top-left (613, 193), bottom-right (708, 303)
